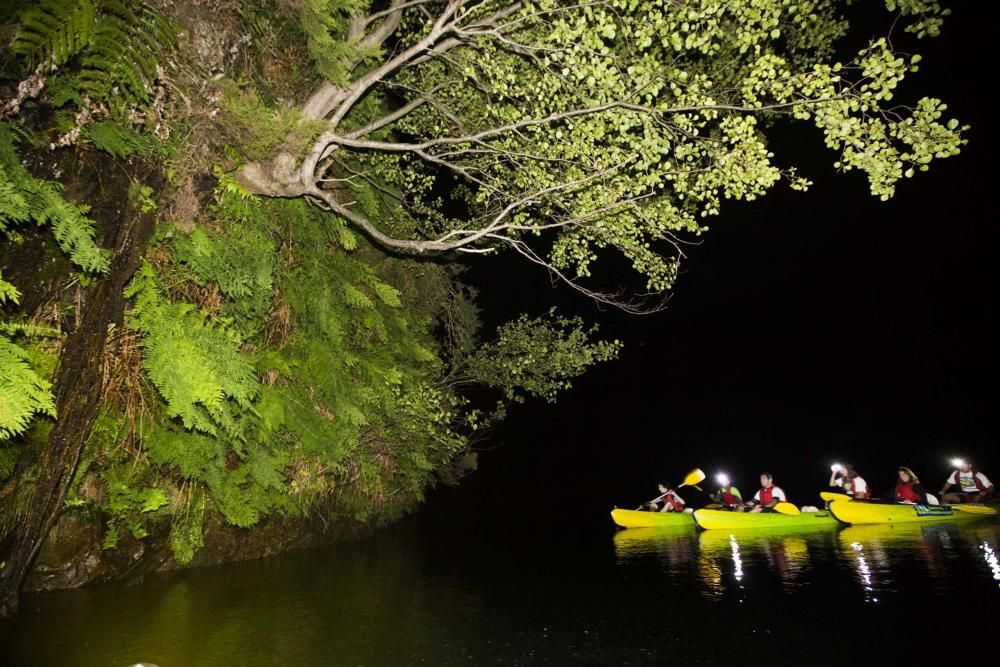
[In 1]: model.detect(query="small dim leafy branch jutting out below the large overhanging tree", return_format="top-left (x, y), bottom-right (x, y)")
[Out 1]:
top-left (469, 310), bottom-right (621, 402)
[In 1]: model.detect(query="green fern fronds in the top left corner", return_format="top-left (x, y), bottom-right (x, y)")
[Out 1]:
top-left (12, 0), bottom-right (176, 117)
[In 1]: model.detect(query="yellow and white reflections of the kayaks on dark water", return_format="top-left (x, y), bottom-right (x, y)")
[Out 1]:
top-left (614, 522), bottom-right (1000, 604)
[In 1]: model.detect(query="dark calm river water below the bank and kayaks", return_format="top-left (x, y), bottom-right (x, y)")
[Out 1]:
top-left (0, 503), bottom-right (1000, 667)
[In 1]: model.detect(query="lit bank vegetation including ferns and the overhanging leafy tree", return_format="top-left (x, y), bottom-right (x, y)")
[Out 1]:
top-left (0, 0), bottom-right (965, 610)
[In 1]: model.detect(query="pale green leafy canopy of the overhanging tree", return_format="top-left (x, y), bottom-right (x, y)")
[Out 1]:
top-left (331, 0), bottom-right (967, 305)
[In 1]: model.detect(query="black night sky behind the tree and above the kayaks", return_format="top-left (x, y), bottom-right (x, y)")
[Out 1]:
top-left (439, 2), bottom-right (1000, 510)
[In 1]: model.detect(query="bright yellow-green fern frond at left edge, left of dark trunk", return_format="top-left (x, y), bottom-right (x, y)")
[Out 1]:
top-left (0, 334), bottom-right (56, 441)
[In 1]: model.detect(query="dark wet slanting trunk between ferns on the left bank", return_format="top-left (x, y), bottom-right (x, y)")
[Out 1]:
top-left (0, 175), bottom-right (155, 616)
